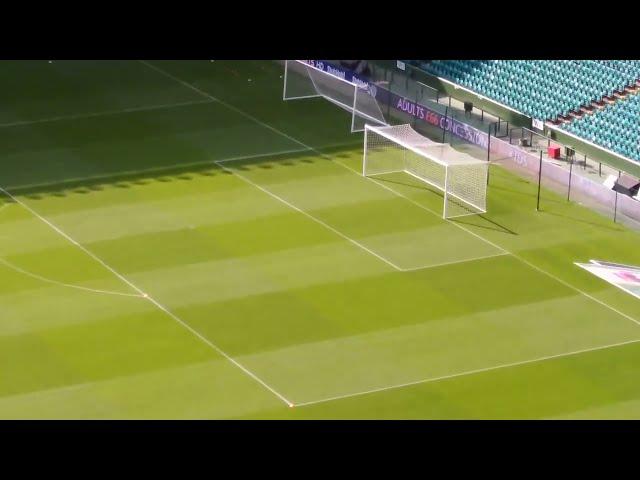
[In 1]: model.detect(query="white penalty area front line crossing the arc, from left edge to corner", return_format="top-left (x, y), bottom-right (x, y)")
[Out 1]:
top-left (0, 187), bottom-right (293, 407)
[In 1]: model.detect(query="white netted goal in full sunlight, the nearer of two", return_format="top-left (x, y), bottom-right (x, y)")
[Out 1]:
top-left (362, 125), bottom-right (489, 218)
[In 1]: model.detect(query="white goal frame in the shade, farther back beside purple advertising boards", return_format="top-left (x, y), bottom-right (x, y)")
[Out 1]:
top-left (282, 60), bottom-right (387, 132)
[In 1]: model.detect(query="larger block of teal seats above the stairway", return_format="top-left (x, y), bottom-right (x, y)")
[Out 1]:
top-left (408, 60), bottom-right (640, 120)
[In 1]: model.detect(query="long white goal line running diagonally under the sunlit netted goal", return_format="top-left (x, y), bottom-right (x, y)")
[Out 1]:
top-left (141, 60), bottom-right (640, 325)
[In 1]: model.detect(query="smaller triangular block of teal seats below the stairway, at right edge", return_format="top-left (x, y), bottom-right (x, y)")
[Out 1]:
top-left (562, 95), bottom-right (640, 161)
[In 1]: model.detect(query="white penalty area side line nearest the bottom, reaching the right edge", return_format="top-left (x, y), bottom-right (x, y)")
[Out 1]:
top-left (295, 339), bottom-right (640, 407)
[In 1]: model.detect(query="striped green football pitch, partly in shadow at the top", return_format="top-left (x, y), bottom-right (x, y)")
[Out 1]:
top-left (0, 61), bottom-right (640, 419)
